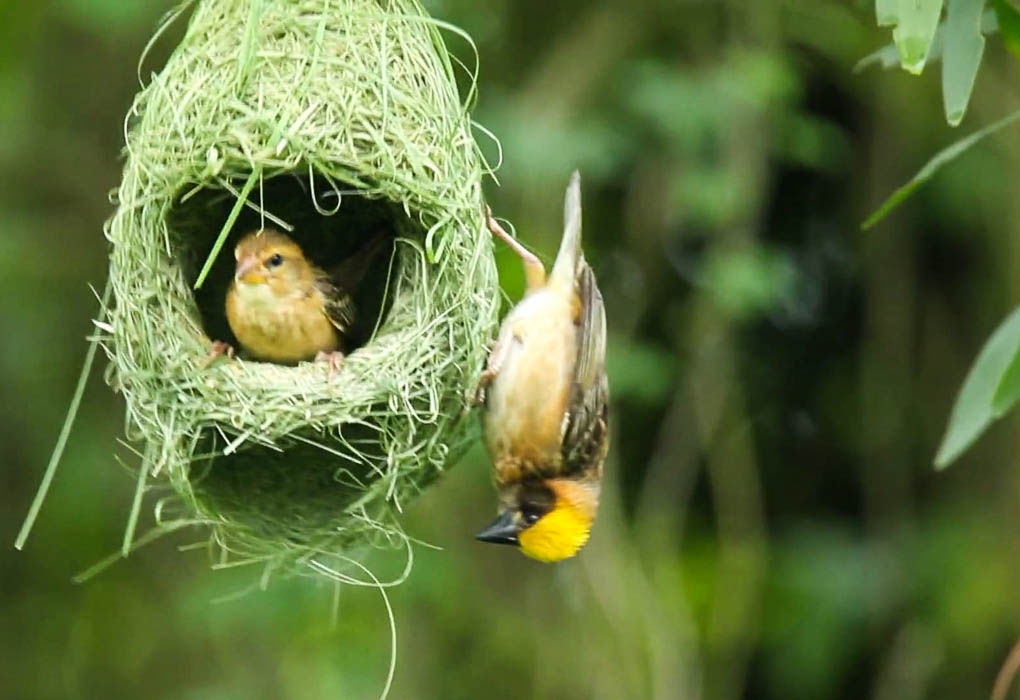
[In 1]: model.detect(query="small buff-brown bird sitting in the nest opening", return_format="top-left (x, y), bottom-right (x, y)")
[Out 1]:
top-left (212, 229), bottom-right (385, 377)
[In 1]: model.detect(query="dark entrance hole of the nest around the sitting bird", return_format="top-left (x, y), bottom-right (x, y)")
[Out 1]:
top-left (167, 174), bottom-right (405, 353)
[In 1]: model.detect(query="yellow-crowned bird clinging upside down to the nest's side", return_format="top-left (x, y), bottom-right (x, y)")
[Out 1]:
top-left (476, 171), bottom-right (609, 562)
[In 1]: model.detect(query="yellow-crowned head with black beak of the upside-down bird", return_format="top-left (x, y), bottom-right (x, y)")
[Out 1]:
top-left (475, 477), bottom-right (599, 562)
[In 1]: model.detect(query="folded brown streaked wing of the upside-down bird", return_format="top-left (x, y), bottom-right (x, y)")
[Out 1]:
top-left (562, 258), bottom-right (609, 476)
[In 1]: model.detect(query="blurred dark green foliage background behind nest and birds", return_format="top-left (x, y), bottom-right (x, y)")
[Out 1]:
top-left (0, 0), bottom-right (1020, 700)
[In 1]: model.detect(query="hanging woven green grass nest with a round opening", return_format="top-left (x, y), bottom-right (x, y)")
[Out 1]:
top-left (101, 0), bottom-right (499, 567)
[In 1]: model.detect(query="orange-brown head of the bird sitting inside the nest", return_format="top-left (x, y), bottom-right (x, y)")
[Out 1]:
top-left (234, 229), bottom-right (314, 296)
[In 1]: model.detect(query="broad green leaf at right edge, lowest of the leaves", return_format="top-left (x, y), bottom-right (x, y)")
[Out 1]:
top-left (935, 308), bottom-right (1020, 469)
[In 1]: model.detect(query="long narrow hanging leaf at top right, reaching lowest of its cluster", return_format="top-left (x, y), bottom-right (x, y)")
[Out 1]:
top-left (942, 0), bottom-right (984, 127)
